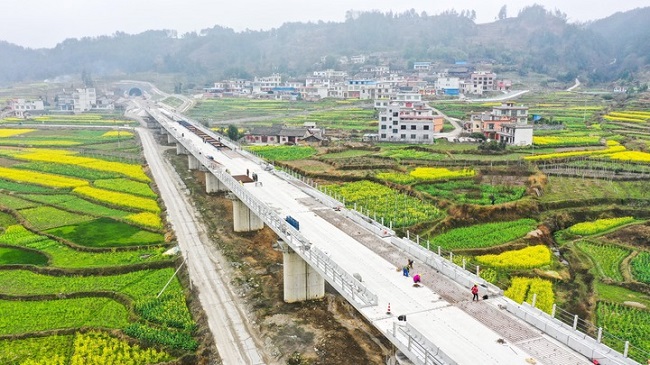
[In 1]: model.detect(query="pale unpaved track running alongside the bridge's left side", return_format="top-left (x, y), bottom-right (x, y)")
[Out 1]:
top-left (136, 128), bottom-right (267, 365)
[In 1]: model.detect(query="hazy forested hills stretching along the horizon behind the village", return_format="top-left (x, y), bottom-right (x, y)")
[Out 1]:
top-left (0, 5), bottom-right (650, 84)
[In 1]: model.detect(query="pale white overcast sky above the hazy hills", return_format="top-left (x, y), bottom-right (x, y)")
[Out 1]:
top-left (0, 0), bottom-right (650, 49)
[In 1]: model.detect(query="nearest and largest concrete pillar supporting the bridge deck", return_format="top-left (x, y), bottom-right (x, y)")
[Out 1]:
top-left (282, 249), bottom-right (325, 303)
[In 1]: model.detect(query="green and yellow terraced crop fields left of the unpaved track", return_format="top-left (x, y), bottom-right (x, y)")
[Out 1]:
top-left (0, 126), bottom-right (198, 365)
